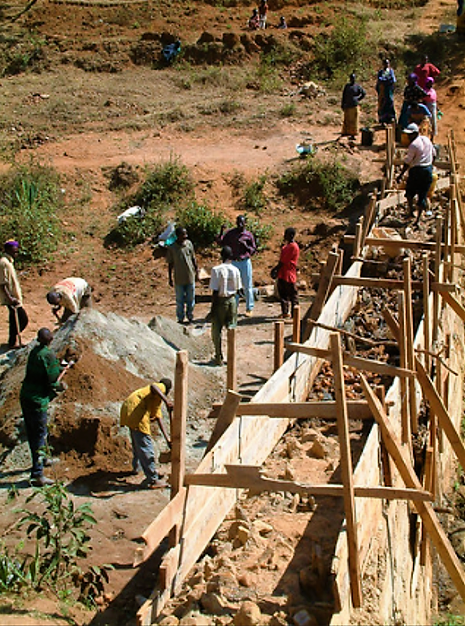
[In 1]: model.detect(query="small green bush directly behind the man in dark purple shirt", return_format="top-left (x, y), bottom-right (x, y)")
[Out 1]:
top-left (176, 202), bottom-right (225, 248)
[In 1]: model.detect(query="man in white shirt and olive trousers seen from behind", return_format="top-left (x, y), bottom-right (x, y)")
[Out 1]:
top-left (210, 246), bottom-right (242, 365)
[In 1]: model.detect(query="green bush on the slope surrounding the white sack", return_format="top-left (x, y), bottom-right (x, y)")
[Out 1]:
top-left (105, 158), bottom-right (194, 248)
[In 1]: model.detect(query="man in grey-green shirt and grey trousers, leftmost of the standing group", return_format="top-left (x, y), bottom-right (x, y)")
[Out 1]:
top-left (166, 226), bottom-right (197, 324)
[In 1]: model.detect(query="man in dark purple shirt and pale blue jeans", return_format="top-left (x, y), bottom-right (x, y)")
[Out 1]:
top-left (218, 215), bottom-right (257, 317)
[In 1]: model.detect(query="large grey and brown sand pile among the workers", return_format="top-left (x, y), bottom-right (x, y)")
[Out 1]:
top-left (0, 309), bottom-right (224, 478)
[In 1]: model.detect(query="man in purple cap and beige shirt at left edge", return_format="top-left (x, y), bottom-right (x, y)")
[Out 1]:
top-left (0, 239), bottom-right (29, 348)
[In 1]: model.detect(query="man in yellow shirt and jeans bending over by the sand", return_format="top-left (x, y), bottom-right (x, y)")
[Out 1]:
top-left (120, 378), bottom-right (173, 489)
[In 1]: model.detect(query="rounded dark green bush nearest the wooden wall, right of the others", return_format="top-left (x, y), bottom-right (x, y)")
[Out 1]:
top-left (277, 156), bottom-right (359, 210)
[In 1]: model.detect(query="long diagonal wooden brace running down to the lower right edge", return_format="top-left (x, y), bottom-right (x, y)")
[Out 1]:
top-left (360, 375), bottom-right (465, 600)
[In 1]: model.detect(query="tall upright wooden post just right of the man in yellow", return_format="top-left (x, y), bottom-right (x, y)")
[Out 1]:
top-left (170, 350), bottom-right (189, 547)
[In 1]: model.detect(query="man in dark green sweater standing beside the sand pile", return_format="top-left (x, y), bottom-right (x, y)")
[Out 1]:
top-left (19, 328), bottom-right (65, 486)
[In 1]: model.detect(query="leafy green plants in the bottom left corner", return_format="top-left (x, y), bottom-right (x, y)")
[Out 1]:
top-left (0, 482), bottom-right (110, 604)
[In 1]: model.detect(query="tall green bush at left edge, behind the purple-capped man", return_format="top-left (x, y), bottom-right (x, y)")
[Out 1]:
top-left (0, 163), bottom-right (62, 266)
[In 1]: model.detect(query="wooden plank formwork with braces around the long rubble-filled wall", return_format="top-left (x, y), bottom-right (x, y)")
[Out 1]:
top-left (136, 134), bottom-right (465, 624)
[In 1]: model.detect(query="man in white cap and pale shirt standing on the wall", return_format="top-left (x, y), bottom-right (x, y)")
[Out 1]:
top-left (397, 123), bottom-right (436, 224)
